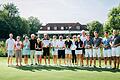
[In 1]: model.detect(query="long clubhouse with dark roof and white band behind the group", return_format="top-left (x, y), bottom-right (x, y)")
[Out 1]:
top-left (37, 22), bottom-right (88, 37)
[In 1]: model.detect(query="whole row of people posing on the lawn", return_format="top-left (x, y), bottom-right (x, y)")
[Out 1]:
top-left (6, 30), bottom-right (120, 68)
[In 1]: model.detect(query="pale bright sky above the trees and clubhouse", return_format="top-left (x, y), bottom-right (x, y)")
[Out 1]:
top-left (0, 0), bottom-right (120, 24)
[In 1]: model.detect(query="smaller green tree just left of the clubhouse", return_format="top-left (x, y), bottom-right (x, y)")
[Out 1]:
top-left (28, 16), bottom-right (42, 34)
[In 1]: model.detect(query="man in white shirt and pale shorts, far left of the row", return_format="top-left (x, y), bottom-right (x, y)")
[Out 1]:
top-left (6, 33), bottom-right (15, 66)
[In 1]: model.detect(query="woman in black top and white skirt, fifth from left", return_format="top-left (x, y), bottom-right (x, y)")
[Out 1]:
top-left (35, 38), bottom-right (43, 65)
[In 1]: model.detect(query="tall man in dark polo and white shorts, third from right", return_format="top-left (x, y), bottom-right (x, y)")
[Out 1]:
top-left (93, 31), bottom-right (102, 68)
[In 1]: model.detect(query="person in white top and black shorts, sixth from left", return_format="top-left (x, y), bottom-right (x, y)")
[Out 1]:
top-left (42, 34), bottom-right (51, 65)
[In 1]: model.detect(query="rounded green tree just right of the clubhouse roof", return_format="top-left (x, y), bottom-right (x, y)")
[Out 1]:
top-left (87, 21), bottom-right (103, 36)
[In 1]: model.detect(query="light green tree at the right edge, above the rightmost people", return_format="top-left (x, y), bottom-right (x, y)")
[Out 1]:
top-left (104, 5), bottom-right (120, 32)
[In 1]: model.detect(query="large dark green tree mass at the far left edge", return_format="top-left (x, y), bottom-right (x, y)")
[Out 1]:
top-left (0, 3), bottom-right (30, 39)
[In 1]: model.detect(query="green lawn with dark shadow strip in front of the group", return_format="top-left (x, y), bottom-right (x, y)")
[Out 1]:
top-left (0, 57), bottom-right (120, 80)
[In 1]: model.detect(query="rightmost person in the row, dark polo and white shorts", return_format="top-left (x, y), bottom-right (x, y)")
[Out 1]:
top-left (111, 30), bottom-right (120, 69)
